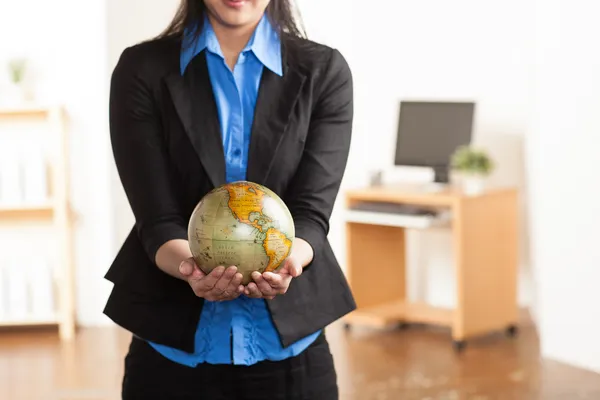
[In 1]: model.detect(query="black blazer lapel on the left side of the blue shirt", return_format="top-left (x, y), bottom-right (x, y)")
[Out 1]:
top-left (166, 53), bottom-right (226, 187)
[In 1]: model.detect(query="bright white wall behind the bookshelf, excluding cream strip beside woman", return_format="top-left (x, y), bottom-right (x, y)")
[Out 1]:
top-left (0, 0), bottom-right (113, 324)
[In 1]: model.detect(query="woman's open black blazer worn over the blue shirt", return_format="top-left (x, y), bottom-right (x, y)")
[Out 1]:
top-left (104, 36), bottom-right (356, 352)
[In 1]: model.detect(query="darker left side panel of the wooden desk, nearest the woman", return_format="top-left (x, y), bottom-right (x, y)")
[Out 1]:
top-left (346, 222), bottom-right (406, 326)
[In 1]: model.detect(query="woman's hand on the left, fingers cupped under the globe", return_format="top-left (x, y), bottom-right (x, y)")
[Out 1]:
top-left (179, 258), bottom-right (244, 301)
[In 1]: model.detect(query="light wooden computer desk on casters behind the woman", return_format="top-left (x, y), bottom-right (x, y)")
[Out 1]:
top-left (345, 186), bottom-right (518, 350)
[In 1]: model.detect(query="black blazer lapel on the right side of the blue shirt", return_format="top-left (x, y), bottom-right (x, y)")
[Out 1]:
top-left (247, 63), bottom-right (306, 184)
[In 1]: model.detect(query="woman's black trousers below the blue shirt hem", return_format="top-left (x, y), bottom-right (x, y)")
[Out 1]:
top-left (122, 334), bottom-right (338, 400)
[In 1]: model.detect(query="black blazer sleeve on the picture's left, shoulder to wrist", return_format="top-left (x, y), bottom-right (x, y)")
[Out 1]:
top-left (109, 47), bottom-right (187, 262)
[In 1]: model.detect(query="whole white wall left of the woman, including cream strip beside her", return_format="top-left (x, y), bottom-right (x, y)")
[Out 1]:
top-left (0, 0), bottom-right (179, 326)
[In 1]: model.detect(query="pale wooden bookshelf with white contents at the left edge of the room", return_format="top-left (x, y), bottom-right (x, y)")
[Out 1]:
top-left (0, 105), bottom-right (75, 340)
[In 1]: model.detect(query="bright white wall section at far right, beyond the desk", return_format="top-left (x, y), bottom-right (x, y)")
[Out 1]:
top-left (527, 0), bottom-right (600, 372)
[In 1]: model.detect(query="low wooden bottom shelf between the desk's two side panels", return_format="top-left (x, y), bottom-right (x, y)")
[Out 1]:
top-left (345, 300), bottom-right (454, 328)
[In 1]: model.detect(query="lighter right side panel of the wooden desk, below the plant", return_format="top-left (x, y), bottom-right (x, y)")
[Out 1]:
top-left (452, 193), bottom-right (518, 342)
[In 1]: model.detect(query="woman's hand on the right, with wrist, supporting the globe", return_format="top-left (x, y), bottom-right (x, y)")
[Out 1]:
top-left (244, 238), bottom-right (314, 300)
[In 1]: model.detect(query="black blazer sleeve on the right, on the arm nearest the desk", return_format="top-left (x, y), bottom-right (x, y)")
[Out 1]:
top-left (287, 50), bottom-right (353, 257)
